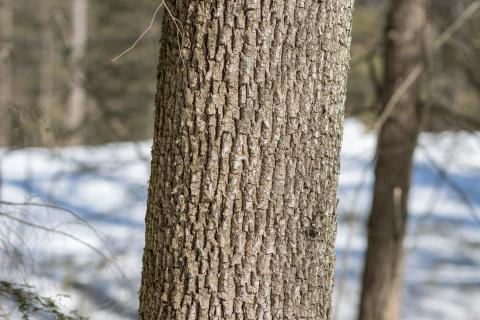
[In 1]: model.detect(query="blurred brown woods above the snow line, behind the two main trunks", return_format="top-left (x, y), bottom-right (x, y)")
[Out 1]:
top-left (0, 0), bottom-right (480, 147)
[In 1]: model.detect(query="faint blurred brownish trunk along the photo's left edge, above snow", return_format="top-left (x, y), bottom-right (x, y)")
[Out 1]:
top-left (0, 0), bottom-right (14, 147)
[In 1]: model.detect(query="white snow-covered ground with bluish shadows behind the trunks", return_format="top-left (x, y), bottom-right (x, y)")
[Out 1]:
top-left (0, 119), bottom-right (480, 320)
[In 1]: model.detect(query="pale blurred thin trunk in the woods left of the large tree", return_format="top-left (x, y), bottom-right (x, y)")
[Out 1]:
top-left (67, 0), bottom-right (88, 130)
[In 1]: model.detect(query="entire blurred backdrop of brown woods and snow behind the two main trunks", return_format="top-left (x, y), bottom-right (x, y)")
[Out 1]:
top-left (0, 0), bottom-right (480, 319)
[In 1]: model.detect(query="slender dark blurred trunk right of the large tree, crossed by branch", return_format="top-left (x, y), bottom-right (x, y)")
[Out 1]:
top-left (359, 0), bottom-right (428, 320)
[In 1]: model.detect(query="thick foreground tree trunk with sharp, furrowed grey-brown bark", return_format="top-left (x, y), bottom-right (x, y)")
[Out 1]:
top-left (139, 0), bottom-right (353, 320)
